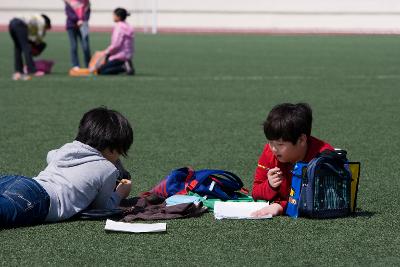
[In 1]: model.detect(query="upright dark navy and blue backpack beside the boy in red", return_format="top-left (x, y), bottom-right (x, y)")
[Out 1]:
top-left (286, 150), bottom-right (352, 218)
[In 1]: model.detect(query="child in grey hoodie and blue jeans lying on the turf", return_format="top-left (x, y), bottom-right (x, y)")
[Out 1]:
top-left (0, 107), bottom-right (133, 227)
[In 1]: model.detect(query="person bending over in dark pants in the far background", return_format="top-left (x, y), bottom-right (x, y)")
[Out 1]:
top-left (8, 14), bottom-right (51, 80)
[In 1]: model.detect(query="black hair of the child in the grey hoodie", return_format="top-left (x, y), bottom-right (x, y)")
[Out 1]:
top-left (76, 107), bottom-right (133, 157)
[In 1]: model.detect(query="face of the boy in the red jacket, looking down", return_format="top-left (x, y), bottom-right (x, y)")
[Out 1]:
top-left (269, 134), bottom-right (307, 163)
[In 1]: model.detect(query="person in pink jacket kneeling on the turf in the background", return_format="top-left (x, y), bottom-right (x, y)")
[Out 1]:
top-left (97, 8), bottom-right (135, 75)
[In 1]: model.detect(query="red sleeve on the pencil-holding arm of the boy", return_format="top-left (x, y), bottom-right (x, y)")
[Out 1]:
top-left (252, 145), bottom-right (278, 200)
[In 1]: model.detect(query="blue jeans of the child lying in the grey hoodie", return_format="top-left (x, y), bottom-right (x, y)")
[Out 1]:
top-left (0, 175), bottom-right (50, 227)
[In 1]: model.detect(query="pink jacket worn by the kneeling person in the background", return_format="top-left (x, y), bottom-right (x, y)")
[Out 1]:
top-left (106, 21), bottom-right (135, 61)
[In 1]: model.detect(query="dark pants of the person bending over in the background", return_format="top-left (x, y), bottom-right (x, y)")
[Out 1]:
top-left (8, 18), bottom-right (36, 73)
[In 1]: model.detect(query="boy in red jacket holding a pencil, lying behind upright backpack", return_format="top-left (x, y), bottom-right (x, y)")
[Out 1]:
top-left (252, 103), bottom-right (333, 217)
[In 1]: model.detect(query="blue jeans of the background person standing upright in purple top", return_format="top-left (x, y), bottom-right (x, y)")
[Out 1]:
top-left (67, 22), bottom-right (91, 68)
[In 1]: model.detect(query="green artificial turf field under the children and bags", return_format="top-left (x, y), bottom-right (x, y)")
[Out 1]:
top-left (0, 32), bottom-right (400, 266)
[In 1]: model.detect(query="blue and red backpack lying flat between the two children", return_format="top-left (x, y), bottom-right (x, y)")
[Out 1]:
top-left (150, 167), bottom-right (245, 200)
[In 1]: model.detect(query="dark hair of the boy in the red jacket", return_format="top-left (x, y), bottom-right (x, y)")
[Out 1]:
top-left (264, 103), bottom-right (312, 144)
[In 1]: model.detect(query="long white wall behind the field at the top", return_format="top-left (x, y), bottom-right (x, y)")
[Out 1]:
top-left (0, 0), bottom-right (400, 33)
